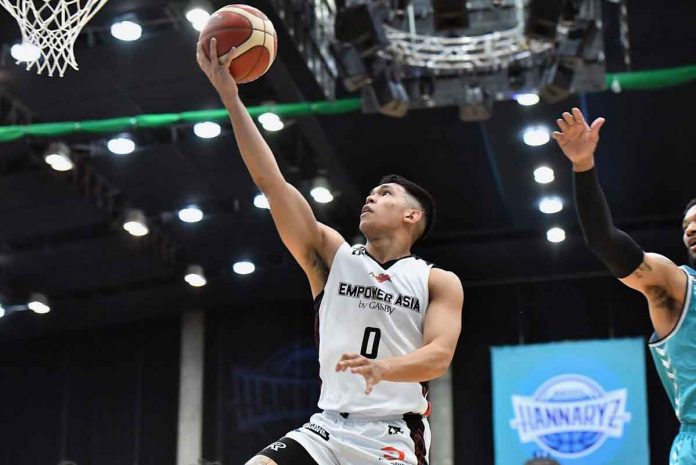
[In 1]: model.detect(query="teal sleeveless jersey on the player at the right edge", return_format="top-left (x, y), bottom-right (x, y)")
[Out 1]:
top-left (649, 266), bottom-right (696, 465)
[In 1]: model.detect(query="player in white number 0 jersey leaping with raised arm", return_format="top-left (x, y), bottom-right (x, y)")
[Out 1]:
top-left (197, 39), bottom-right (464, 465)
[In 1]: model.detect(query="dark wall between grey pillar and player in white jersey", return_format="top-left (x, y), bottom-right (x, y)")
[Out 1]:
top-left (203, 300), bottom-right (320, 464)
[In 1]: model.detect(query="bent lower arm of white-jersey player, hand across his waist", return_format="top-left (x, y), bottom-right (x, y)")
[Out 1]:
top-left (336, 268), bottom-right (464, 394)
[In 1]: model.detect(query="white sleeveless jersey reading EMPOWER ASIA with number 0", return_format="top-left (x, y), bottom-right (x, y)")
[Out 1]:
top-left (315, 243), bottom-right (432, 417)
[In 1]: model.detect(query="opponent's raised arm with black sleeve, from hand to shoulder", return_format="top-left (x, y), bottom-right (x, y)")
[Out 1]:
top-left (553, 108), bottom-right (687, 336)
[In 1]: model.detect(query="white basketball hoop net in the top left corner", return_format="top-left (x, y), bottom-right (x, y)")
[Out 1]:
top-left (0, 0), bottom-right (108, 77)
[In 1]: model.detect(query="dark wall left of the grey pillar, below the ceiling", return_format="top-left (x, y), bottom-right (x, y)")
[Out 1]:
top-left (0, 315), bottom-right (179, 465)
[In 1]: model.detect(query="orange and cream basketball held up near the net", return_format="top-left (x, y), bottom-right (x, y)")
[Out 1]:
top-left (198, 4), bottom-right (278, 84)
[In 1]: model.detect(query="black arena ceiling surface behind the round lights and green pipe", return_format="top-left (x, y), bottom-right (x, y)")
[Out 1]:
top-left (0, 0), bottom-right (696, 338)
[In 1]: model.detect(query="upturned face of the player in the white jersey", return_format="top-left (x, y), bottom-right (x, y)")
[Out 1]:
top-left (360, 183), bottom-right (412, 237)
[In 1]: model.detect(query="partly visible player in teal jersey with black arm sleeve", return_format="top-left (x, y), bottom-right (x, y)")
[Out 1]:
top-left (553, 108), bottom-right (696, 465)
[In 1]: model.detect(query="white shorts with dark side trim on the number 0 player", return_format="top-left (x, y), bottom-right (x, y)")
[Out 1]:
top-left (286, 412), bottom-right (430, 465)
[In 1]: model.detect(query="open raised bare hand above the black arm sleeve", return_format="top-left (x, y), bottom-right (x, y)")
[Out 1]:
top-left (553, 108), bottom-right (604, 171)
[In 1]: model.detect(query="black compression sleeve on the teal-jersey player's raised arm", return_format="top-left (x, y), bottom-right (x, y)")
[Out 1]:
top-left (574, 168), bottom-right (643, 278)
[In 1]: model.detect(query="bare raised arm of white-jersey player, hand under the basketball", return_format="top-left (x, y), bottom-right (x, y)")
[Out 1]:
top-left (196, 38), bottom-right (343, 294)
